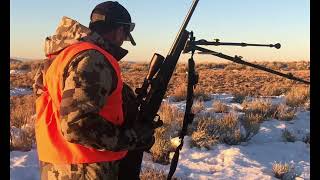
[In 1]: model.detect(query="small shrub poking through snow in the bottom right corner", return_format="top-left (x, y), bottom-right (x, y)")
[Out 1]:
top-left (272, 162), bottom-right (299, 180)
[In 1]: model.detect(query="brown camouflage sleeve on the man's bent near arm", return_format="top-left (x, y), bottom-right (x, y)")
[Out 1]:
top-left (60, 50), bottom-right (138, 151)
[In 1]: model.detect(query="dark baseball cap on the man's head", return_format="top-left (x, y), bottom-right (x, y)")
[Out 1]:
top-left (90, 1), bottom-right (136, 46)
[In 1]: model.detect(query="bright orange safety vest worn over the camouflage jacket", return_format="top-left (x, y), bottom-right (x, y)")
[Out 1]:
top-left (35, 42), bottom-right (127, 164)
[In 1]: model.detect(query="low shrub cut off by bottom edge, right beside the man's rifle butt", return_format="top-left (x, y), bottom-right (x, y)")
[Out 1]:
top-left (140, 168), bottom-right (178, 180)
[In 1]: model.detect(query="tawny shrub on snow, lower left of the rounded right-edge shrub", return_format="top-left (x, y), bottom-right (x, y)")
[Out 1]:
top-left (242, 99), bottom-right (276, 120)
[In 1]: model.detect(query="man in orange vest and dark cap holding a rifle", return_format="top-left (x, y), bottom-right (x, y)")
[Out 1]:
top-left (34, 1), bottom-right (154, 180)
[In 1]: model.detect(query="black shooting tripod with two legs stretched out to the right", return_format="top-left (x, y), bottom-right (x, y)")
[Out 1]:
top-left (167, 31), bottom-right (310, 180)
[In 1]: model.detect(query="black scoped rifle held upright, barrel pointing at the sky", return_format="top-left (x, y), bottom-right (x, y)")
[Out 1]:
top-left (131, 0), bottom-right (199, 177)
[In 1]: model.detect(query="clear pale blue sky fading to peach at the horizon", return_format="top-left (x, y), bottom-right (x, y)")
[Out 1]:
top-left (10, 0), bottom-right (310, 62)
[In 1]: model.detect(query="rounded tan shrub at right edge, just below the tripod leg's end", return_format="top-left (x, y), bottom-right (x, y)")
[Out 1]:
top-left (285, 87), bottom-right (310, 107)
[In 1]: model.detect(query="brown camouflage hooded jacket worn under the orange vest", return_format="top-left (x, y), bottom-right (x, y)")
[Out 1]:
top-left (33, 17), bottom-right (146, 151)
